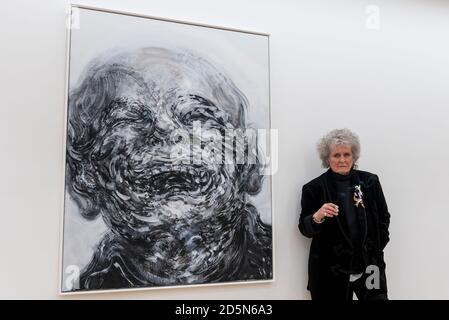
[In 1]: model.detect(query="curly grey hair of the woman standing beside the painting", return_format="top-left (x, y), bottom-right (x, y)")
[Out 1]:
top-left (317, 128), bottom-right (360, 169)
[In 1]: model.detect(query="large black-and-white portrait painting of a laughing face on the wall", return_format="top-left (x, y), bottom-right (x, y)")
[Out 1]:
top-left (60, 6), bottom-right (273, 293)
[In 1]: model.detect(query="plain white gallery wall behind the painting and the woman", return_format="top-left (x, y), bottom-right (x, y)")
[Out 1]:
top-left (0, 0), bottom-right (449, 299)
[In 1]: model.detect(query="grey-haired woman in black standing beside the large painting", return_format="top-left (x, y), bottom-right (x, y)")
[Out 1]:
top-left (298, 129), bottom-right (390, 300)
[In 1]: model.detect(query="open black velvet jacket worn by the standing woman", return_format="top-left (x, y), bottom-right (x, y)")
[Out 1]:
top-left (298, 169), bottom-right (390, 295)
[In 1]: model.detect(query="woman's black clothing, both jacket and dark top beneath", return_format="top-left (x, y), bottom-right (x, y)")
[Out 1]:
top-left (298, 169), bottom-right (390, 300)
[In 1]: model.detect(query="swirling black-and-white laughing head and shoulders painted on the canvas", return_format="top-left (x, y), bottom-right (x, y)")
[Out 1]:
top-left (67, 48), bottom-right (271, 289)
